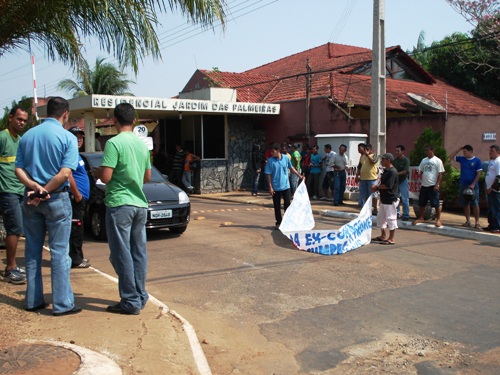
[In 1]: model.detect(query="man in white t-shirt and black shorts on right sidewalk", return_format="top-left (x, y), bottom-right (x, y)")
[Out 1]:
top-left (413, 145), bottom-right (444, 228)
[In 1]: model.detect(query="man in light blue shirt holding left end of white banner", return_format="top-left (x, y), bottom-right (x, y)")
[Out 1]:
top-left (264, 143), bottom-right (304, 229)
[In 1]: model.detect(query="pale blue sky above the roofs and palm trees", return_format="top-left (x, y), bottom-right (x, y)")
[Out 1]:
top-left (0, 0), bottom-right (473, 108)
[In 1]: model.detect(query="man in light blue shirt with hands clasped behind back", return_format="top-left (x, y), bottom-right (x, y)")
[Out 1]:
top-left (16, 97), bottom-right (82, 316)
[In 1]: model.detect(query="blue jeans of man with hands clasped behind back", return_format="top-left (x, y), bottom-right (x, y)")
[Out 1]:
top-left (23, 192), bottom-right (75, 313)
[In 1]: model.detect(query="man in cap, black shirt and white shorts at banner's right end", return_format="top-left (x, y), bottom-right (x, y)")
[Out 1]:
top-left (371, 153), bottom-right (399, 245)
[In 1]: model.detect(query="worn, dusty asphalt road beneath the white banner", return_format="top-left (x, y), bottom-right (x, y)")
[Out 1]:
top-left (85, 198), bottom-right (500, 374)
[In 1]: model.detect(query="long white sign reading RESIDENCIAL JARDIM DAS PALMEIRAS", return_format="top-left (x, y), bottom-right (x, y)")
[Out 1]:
top-left (92, 95), bottom-right (280, 115)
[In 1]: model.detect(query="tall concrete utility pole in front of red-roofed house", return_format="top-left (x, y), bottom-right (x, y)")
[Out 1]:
top-left (370, 0), bottom-right (386, 155)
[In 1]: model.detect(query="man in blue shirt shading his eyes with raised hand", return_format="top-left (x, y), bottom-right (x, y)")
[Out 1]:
top-left (449, 145), bottom-right (483, 229)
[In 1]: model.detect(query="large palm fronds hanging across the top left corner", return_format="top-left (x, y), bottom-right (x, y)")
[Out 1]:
top-left (0, 0), bottom-right (225, 73)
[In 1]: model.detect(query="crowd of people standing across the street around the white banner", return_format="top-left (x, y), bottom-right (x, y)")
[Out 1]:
top-left (252, 142), bottom-right (500, 244)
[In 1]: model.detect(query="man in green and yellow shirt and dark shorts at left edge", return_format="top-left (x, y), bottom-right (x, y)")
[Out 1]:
top-left (0, 106), bottom-right (28, 285)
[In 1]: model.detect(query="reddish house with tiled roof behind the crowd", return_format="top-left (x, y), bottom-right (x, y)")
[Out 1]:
top-left (180, 43), bottom-right (500, 164)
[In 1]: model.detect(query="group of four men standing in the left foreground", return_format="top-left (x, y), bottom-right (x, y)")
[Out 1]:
top-left (0, 97), bottom-right (151, 316)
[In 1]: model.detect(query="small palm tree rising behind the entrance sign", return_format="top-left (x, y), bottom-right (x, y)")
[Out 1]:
top-left (57, 57), bottom-right (135, 98)
